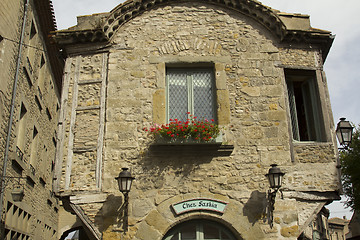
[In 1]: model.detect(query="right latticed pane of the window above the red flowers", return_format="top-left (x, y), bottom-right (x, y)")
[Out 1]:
top-left (192, 70), bottom-right (215, 120)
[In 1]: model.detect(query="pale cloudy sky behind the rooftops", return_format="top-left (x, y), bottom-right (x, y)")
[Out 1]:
top-left (52, 0), bottom-right (360, 219)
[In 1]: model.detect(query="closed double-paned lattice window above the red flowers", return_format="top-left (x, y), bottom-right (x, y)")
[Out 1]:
top-left (166, 68), bottom-right (216, 121)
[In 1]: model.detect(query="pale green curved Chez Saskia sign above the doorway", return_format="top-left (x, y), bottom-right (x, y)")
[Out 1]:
top-left (172, 198), bottom-right (228, 215)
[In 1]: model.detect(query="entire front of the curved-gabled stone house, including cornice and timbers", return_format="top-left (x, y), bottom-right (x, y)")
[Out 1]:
top-left (54, 0), bottom-right (340, 240)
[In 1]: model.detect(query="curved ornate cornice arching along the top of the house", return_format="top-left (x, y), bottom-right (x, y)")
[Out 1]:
top-left (103, 0), bottom-right (286, 40)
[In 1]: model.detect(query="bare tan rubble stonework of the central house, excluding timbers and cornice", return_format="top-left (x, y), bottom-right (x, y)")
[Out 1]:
top-left (55, 2), bottom-right (338, 239)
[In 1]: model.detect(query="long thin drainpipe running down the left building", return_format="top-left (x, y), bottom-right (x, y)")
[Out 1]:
top-left (0, 0), bottom-right (29, 227)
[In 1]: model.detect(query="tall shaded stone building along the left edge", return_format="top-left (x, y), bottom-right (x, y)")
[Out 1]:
top-left (0, 0), bottom-right (63, 239)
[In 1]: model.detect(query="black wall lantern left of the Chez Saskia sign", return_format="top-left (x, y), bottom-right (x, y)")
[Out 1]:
top-left (115, 168), bottom-right (135, 232)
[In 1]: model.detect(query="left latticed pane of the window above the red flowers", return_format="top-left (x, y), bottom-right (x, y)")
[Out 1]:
top-left (168, 71), bottom-right (188, 121)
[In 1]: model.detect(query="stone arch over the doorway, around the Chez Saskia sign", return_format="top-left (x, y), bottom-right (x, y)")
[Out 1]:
top-left (136, 193), bottom-right (264, 240)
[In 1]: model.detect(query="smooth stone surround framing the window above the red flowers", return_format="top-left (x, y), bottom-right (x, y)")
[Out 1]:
top-left (149, 56), bottom-right (231, 125)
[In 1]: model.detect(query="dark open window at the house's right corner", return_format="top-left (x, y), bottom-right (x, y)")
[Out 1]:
top-left (285, 70), bottom-right (323, 141)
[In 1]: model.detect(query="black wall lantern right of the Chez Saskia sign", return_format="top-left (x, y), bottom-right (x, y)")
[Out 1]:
top-left (265, 164), bottom-right (285, 228)
